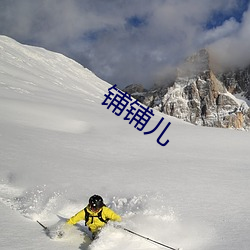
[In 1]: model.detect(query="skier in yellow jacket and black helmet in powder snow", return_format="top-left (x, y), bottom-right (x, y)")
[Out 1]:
top-left (67, 194), bottom-right (122, 239)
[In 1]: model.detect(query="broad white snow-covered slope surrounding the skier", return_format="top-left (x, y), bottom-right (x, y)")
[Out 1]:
top-left (0, 36), bottom-right (250, 250)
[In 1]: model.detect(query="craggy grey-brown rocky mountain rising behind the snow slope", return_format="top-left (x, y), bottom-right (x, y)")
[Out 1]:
top-left (125, 49), bottom-right (250, 129)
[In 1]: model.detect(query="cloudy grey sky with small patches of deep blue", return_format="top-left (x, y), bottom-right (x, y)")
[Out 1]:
top-left (0, 0), bottom-right (250, 88)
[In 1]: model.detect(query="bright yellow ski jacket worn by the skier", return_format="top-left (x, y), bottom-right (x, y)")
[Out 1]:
top-left (67, 206), bottom-right (122, 233)
